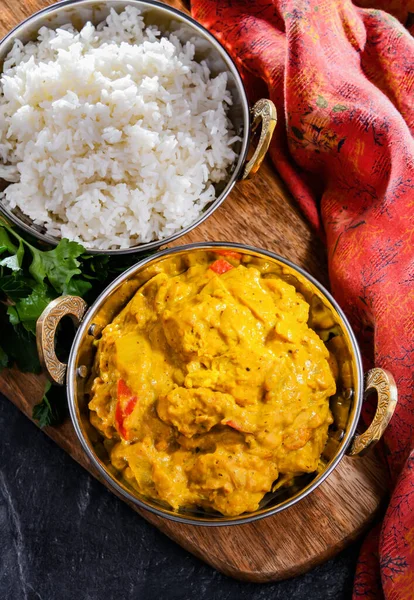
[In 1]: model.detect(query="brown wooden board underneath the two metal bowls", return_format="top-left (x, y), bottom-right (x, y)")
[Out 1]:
top-left (0, 0), bottom-right (388, 582)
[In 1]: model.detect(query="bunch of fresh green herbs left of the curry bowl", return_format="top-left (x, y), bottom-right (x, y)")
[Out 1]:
top-left (0, 220), bottom-right (143, 427)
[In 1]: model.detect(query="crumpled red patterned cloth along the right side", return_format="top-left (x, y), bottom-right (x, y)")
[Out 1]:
top-left (192, 0), bottom-right (414, 600)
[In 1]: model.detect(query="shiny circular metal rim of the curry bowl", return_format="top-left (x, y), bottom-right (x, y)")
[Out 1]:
top-left (66, 242), bottom-right (363, 527)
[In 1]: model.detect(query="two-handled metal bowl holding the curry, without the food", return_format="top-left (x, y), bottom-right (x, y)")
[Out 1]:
top-left (37, 243), bottom-right (397, 526)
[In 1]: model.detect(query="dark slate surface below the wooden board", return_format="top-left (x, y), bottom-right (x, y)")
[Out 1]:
top-left (0, 398), bottom-right (358, 600)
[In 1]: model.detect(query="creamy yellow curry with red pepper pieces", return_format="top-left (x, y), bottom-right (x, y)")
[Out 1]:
top-left (89, 251), bottom-right (335, 516)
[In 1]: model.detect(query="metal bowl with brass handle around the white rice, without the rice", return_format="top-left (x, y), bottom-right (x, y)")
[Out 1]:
top-left (0, 0), bottom-right (276, 254)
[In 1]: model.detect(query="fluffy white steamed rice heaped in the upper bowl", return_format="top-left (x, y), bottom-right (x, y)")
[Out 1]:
top-left (0, 6), bottom-right (239, 249)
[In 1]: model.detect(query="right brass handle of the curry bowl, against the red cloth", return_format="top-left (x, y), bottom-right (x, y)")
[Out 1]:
top-left (347, 369), bottom-right (398, 456)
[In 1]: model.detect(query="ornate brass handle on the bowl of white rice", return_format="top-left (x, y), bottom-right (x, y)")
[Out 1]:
top-left (242, 98), bottom-right (277, 179)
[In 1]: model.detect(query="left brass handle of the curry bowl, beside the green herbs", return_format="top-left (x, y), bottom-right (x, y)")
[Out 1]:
top-left (36, 296), bottom-right (88, 385)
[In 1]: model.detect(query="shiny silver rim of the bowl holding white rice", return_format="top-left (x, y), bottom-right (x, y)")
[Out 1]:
top-left (0, 0), bottom-right (251, 256)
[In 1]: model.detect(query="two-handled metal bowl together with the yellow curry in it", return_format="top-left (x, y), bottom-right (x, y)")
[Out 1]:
top-left (37, 243), bottom-right (397, 525)
